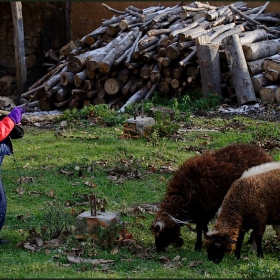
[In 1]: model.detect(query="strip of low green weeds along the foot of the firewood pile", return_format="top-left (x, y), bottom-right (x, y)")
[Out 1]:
top-left (61, 91), bottom-right (220, 127)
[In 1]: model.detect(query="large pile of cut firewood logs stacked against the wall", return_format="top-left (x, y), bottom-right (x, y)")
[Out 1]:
top-left (20, 2), bottom-right (280, 111)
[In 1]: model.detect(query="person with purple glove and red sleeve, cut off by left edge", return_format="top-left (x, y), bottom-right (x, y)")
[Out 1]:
top-left (0, 107), bottom-right (24, 245)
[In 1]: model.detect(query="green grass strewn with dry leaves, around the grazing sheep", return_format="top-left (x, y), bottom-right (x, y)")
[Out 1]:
top-left (0, 113), bottom-right (280, 278)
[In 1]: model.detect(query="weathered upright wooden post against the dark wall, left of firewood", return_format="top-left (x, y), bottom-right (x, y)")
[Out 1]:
top-left (11, 2), bottom-right (27, 97)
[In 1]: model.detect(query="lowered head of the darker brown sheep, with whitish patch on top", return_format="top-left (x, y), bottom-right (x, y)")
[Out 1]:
top-left (150, 215), bottom-right (184, 252)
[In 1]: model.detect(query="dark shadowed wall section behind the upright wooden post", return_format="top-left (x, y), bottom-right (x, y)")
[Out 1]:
top-left (0, 2), bottom-right (69, 87)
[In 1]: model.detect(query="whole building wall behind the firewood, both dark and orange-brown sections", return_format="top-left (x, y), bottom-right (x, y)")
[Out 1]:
top-left (0, 1), bottom-right (280, 94)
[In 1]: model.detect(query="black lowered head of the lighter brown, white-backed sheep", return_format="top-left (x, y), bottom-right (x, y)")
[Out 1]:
top-left (203, 233), bottom-right (236, 263)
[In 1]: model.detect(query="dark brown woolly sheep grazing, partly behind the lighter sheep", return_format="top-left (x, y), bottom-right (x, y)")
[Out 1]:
top-left (150, 144), bottom-right (273, 252)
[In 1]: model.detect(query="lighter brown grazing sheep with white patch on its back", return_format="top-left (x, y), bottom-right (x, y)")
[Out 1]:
top-left (203, 162), bottom-right (280, 263)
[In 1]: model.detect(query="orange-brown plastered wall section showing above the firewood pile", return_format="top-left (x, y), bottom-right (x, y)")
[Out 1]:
top-left (70, 1), bottom-right (280, 40)
